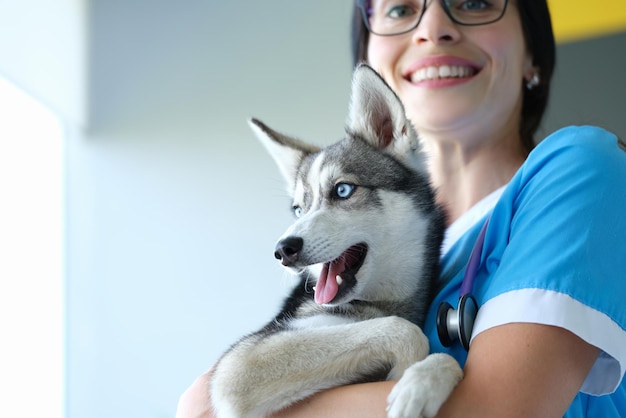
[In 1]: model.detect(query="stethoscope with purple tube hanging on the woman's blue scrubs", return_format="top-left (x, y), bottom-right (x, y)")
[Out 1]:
top-left (437, 218), bottom-right (489, 350)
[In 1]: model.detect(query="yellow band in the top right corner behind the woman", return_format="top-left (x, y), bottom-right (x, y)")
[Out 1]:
top-left (548, 0), bottom-right (626, 42)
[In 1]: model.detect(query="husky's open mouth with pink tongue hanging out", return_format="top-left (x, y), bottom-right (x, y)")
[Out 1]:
top-left (315, 244), bottom-right (367, 304)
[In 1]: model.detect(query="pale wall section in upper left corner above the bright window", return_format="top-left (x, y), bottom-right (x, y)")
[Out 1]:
top-left (0, 0), bottom-right (87, 124)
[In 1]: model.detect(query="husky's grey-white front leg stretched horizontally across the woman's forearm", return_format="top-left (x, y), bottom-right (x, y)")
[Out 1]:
top-left (211, 317), bottom-right (428, 418)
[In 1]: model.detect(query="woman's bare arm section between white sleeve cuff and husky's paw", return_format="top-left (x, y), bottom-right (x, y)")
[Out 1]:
top-left (438, 323), bottom-right (599, 418)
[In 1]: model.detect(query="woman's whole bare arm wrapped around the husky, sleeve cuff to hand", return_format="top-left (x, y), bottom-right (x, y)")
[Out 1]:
top-left (176, 323), bottom-right (599, 418)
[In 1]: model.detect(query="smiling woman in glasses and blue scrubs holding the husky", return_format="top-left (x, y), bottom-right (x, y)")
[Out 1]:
top-left (177, 0), bottom-right (626, 418)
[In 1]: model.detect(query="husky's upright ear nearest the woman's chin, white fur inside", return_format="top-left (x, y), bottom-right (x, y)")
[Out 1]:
top-left (346, 64), bottom-right (420, 170)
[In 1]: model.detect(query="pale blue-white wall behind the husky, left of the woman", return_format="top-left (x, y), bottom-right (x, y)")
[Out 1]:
top-left (0, 0), bottom-right (351, 418)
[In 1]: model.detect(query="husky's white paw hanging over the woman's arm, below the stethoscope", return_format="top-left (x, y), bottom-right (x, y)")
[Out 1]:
top-left (387, 354), bottom-right (463, 418)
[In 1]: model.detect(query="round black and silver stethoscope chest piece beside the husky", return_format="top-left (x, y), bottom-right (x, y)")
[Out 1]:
top-left (437, 294), bottom-right (478, 350)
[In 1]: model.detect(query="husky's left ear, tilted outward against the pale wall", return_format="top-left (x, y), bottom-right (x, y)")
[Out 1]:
top-left (248, 118), bottom-right (320, 193)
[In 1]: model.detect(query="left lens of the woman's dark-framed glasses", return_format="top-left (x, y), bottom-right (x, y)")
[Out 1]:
top-left (366, 0), bottom-right (424, 35)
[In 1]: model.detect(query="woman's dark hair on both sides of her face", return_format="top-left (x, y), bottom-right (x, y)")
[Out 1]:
top-left (352, 0), bottom-right (556, 152)
